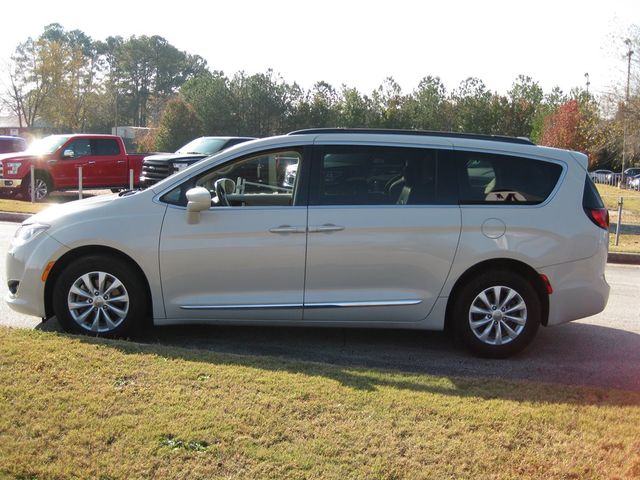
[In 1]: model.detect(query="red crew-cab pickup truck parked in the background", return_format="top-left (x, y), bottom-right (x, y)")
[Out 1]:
top-left (0, 134), bottom-right (145, 200)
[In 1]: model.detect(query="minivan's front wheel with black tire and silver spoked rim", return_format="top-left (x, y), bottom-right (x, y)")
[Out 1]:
top-left (53, 255), bottom-right (149, 338)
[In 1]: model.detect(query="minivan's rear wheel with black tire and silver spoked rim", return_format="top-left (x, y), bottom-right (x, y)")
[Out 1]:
top-left (452, 270), bottom-right (542, 358)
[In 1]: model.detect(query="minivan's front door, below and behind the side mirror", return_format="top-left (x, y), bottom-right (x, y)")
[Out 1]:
top-left (160, 149), bottom-right (307, 322)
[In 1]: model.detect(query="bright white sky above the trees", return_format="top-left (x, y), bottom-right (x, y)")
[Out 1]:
top-left (0, 0), bottom-right (640, 97)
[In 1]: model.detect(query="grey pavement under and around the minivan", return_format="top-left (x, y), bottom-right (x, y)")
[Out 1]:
top-left (0, 222), bottom-right (640, 391)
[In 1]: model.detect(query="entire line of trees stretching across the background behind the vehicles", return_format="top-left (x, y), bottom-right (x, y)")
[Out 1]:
top-left (1, 24), bottom-right (640, 168)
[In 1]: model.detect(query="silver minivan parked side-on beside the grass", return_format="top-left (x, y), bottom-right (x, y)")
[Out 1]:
top-left (7, 129), bottom-right (609, 357)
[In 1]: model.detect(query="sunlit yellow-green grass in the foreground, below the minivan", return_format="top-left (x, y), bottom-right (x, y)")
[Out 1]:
top-left (0, 328), bottom-right (640, 480)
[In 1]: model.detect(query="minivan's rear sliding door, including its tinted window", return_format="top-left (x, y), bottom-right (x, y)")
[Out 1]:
top-left (304, 142), bottom-right (461, 323)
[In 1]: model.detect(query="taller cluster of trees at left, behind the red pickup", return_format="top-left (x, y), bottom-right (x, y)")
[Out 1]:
top-left (1, 23), bottom-right (207, 132)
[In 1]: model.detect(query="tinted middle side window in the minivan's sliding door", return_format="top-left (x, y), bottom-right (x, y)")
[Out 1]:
top-left (310, 145), bottom-right (455, 205)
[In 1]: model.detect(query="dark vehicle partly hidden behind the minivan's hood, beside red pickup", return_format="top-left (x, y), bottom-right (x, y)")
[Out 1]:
top-left (140, 137), bottom-right (255, 187)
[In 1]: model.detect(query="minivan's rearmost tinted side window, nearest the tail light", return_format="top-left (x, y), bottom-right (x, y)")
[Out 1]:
top-left (455, 152), bottom-right (562, 205)
